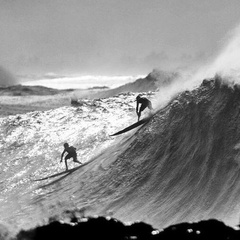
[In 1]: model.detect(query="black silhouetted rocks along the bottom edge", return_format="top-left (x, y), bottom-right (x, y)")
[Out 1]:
top-left (15, 217), bottom-right (240, 240)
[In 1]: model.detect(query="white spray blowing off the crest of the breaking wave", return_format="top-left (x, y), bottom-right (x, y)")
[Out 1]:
top-left (153, 25), bottom-right (240, 108)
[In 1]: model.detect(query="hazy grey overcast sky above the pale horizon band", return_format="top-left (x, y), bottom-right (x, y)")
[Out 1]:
top-left (0, 0), bottom-right (240, 75)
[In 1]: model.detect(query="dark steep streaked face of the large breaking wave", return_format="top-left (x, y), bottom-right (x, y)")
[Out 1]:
top-left (86, 79), bottom-right (240, 227)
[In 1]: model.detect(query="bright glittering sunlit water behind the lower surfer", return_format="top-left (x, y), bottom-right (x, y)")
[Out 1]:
top-left (0, 93), bottom-right (152, 232)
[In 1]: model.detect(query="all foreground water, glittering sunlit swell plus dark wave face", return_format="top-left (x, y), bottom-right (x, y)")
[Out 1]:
top-left (0, 78), bottom-right (240, 237)
